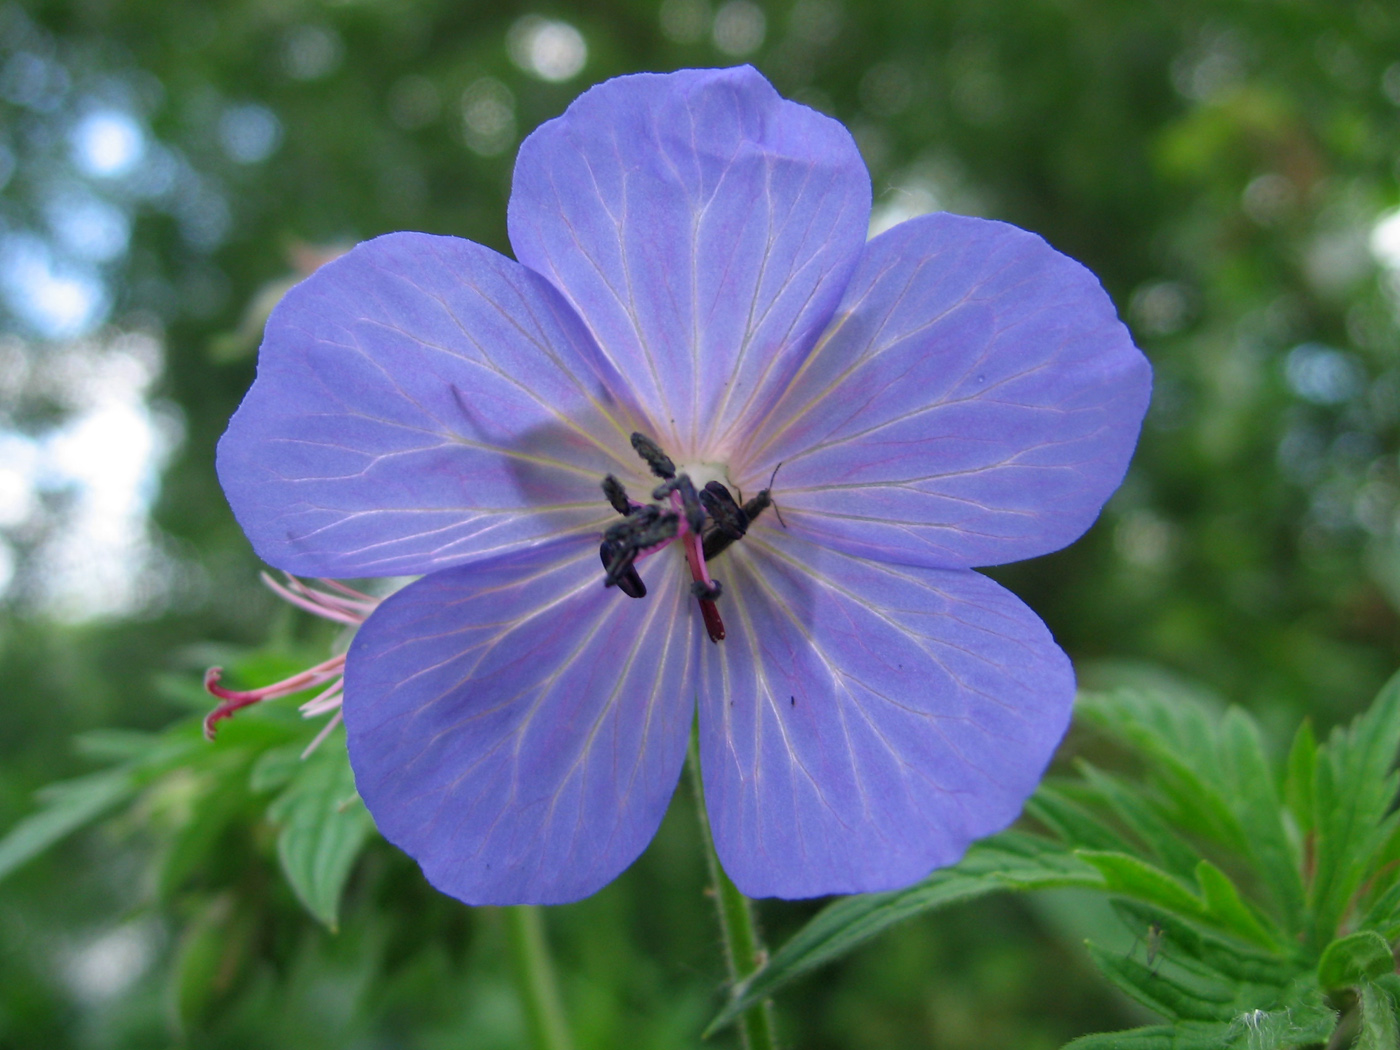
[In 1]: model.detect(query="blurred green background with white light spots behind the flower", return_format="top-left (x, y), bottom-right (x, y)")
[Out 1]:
top-left (0, 0), bottom-right (1400, 1050)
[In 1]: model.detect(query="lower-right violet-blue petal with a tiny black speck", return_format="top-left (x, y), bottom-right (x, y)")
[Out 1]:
top-left (700, 528), bottom-right (1074, 897)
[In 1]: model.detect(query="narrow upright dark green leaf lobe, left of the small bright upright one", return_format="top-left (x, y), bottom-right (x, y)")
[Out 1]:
top-left (1219, 707), bottom-right (1306, 934)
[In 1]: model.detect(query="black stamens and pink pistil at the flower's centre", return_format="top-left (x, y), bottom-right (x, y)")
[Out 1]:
top-left (598, 434), bottom-right (773, 641)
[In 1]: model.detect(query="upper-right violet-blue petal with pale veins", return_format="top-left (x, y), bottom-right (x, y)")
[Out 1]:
top-left (743, 214), bottom-right (1151, 568)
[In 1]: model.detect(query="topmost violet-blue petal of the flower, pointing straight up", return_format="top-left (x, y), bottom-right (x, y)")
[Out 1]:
top-left (510, 67), bottom-right (871, 459)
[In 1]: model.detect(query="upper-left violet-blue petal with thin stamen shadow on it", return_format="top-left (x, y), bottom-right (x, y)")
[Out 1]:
top-left (217, 234), bottom-right (649, 577)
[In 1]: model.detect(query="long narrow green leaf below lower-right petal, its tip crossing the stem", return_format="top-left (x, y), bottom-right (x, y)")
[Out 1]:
top-left (706, 832), bottom-right (1103, 1035)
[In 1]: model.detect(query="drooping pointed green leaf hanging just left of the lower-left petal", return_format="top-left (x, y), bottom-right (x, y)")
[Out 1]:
top-left (267, 741), bottom-right (374, 930)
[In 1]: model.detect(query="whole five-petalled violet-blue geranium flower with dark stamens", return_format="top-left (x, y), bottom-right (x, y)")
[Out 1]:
top-left (218, 69), bottom-right (1149, 904)
